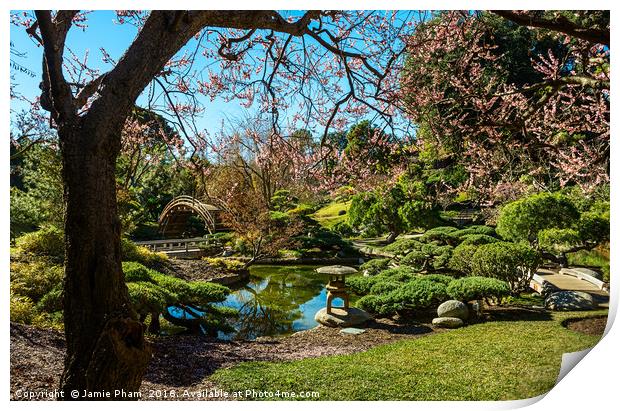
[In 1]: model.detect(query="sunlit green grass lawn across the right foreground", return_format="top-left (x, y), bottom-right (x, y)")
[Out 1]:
top-left (211, 311), bottom-right (606, 401)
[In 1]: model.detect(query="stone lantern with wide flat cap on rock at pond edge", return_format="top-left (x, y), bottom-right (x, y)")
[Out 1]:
top-left (314, 265), bottom-right (370, 327)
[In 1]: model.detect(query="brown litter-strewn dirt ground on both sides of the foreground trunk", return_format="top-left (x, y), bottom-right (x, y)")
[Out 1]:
top-left (11, 319), bottom-right (444, 400)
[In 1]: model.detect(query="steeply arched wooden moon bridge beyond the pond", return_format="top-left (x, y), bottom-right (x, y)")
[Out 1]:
top-left (158, 196), bottom-right (220, 238)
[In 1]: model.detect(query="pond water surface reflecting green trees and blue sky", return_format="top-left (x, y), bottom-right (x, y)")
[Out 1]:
top-left (220, 265), bottom-right (358, 339)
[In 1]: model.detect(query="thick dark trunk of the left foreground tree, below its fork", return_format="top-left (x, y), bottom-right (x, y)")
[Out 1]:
top-left (58, 117), bottom-right (151, 399)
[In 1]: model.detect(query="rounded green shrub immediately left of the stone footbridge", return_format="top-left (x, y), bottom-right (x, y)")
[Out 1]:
top-left (471, 242), bottom-right (540, 294)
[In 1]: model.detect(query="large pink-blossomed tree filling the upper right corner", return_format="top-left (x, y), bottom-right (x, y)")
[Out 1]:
top-left (401, 11), bottom-right (610, 198)
